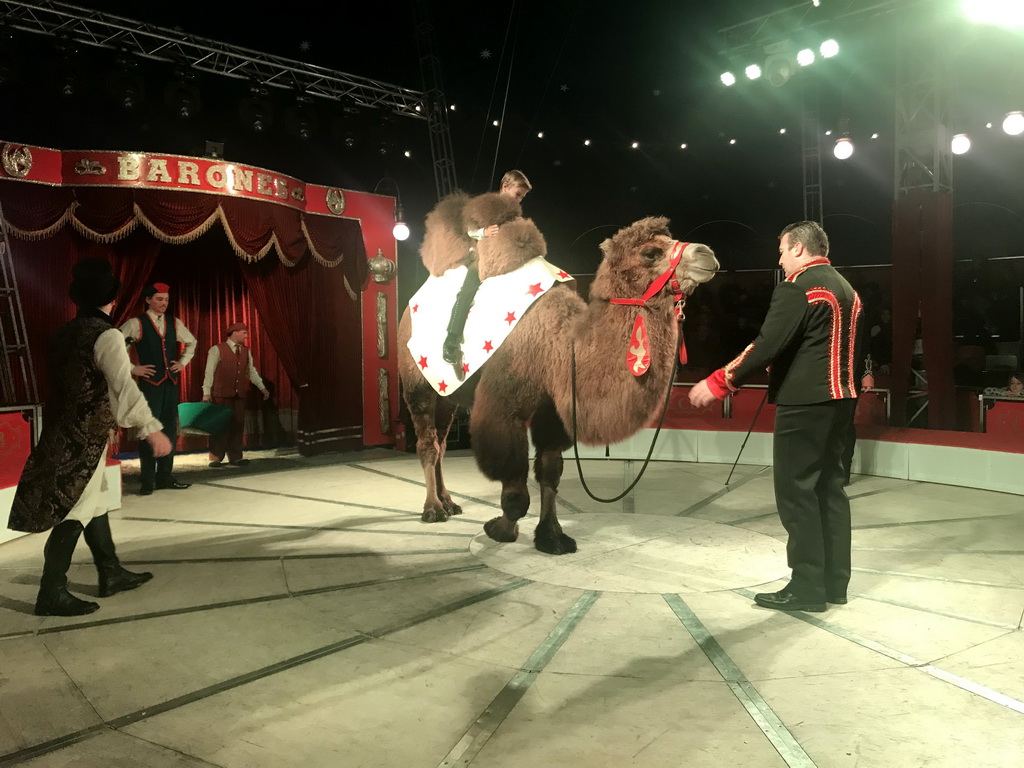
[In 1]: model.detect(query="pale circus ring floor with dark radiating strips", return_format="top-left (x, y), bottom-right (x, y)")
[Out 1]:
top-left (0, 451), bottom-right (1024, 768)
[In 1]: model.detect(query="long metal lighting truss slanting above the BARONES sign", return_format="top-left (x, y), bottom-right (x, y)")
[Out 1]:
top-left (0, 0), bottom-right (427, 120)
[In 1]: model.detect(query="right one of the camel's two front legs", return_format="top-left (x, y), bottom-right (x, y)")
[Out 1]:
top-left (529, 400), bottom-right (577, 555)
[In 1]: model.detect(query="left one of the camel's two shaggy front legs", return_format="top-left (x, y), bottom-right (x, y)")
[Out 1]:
top-left (469, 392), bottom-right (529, 542)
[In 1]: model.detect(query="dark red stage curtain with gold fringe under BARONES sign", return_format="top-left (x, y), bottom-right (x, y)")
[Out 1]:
top-left (0, 183), bottom-right (369, 454)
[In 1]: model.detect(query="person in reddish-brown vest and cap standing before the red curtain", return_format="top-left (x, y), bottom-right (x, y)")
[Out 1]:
top-left (203, 323), bottom-right (270, 467)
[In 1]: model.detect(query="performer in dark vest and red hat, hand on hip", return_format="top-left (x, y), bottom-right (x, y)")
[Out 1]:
top-left (121, 283), bottom-right (196, 496)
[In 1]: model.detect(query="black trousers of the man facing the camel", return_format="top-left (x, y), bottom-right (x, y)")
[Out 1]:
top-left (773, 399), bottom-right (857, 602)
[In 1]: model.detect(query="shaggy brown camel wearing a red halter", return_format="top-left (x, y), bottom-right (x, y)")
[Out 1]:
top-left (398, 214), bottom-right (719, 555)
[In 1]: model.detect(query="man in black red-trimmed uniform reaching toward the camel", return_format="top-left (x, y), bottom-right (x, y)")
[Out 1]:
top-left (690, 221), bottom-right (862, 611)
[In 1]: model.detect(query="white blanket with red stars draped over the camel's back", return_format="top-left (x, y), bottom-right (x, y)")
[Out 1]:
top-left (409, 256), bottom-right (572, 395)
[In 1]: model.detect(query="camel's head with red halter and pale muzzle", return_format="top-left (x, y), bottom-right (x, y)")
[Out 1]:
top-left (591, 216), bottom-right (718, 299)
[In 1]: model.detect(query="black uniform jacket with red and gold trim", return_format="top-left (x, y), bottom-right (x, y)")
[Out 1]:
top-left (709, 259), bottom-right (863, 406)
